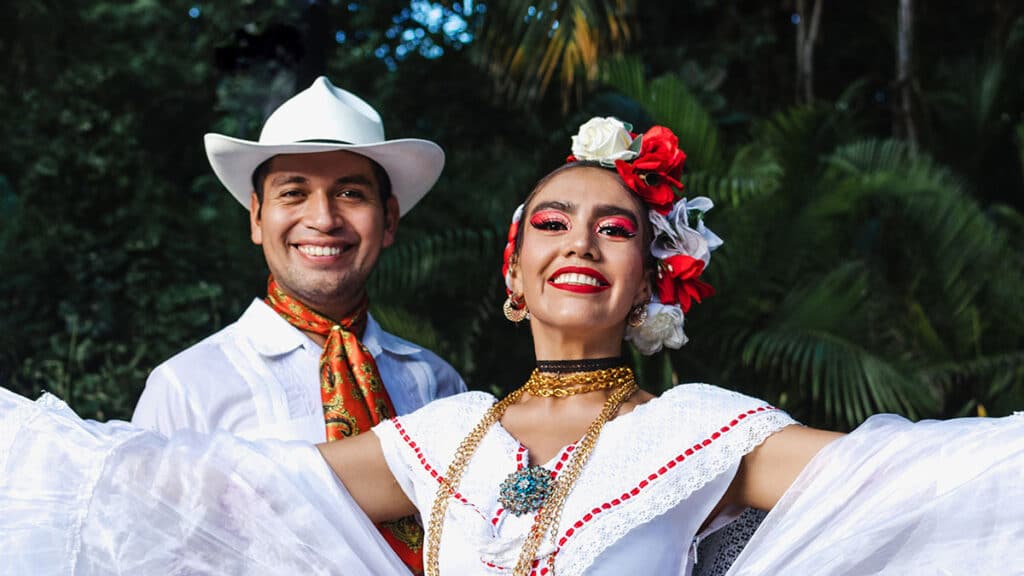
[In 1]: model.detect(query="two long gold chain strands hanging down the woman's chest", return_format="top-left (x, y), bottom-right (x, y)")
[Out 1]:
top-left (424, 368), bottom-right (637, 576)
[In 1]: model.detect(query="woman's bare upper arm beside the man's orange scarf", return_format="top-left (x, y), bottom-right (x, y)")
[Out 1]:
top-left (316, 433), bottom-right (417, 523)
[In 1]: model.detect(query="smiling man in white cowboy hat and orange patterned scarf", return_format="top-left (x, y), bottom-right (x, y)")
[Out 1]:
top-left (132, 77), bottom-right (465, 571)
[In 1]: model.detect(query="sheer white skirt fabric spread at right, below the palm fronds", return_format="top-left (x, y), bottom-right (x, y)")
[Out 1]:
top-left (729, 415), bottom-right (1024, 576)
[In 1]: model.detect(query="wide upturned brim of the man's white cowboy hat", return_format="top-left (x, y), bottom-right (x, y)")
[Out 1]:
top-left (203, 133), bottom-right (444, 215)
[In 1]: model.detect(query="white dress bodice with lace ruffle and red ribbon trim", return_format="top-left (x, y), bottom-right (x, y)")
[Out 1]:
top-left (374, 384), bottom-right (795, 576)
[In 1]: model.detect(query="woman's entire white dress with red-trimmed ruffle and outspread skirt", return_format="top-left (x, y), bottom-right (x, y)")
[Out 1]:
top-left (0, 385), bottom-right (1024, 576)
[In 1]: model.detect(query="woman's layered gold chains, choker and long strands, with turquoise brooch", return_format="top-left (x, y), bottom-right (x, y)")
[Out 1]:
top-left (424, 362), bottom-right (637, 576)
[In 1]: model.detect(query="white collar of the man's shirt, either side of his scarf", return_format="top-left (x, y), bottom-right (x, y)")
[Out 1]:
top-left (239, 298), bottom-right (422, 357)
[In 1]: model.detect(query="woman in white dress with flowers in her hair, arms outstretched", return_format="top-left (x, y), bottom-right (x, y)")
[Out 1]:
top-left (0, 119), bottom-right (1024, 575)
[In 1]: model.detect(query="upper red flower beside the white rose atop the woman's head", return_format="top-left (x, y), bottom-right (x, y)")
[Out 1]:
top-left (615, 126), bottom-right (686, 214)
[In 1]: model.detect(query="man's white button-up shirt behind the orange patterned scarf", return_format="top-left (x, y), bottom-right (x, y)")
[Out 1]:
top-left (132, 299), bottom-right (466, 443)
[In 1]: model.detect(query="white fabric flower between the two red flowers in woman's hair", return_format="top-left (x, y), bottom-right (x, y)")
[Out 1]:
top-left (648, 196), bottom-right (722, 265)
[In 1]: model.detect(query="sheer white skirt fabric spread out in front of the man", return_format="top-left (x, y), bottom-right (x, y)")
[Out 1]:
top-left (0, 389), bottom-right (409, 576)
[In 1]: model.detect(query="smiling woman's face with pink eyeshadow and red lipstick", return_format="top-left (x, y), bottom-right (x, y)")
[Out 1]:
top-left (512, 167), bottom-right (650, 337)
